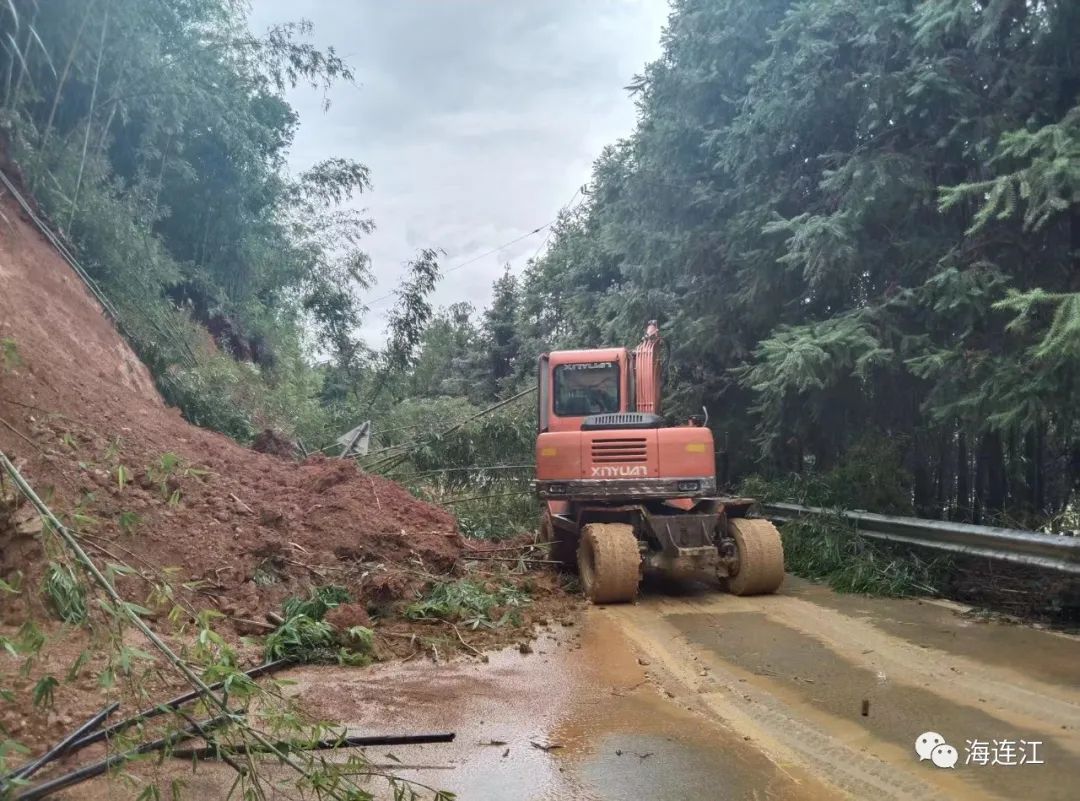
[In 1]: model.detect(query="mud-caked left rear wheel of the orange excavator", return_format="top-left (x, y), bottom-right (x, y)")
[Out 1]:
top-left (578, 522), bottom-right (642, 603)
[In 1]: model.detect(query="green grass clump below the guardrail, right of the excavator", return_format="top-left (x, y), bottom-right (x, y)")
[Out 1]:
top-left (781, 518), bottom-right (951, 597)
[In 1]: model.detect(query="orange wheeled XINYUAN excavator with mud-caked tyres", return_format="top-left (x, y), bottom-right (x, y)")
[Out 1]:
top-left (534, 321), bottom-right (784, 603)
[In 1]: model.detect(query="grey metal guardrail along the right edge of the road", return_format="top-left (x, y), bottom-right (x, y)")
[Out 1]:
top-left (759, 503), bottom-right (1080, 575)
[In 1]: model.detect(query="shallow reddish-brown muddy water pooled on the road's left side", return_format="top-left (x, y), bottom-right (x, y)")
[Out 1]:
top-left (282, 611), bottom-right (831, 801)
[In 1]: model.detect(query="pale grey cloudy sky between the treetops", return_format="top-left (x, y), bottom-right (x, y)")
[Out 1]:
top-left (251, 0), bottom-right (667, 345)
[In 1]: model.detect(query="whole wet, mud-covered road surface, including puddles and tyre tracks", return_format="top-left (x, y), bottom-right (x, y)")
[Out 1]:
top-left (111, 580), bottom-right (1080, 801)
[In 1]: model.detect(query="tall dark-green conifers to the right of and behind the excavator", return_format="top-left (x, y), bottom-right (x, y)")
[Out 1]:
top-left (517, 0), bottom-right (1080, 531)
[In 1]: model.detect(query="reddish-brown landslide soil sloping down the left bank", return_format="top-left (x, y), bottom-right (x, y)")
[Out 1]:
top-left (0, 184), bottom-right (462, 624)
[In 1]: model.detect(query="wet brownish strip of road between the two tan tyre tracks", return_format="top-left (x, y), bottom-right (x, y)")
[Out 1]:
top-left (667, 612), bottom-right (1078, 801)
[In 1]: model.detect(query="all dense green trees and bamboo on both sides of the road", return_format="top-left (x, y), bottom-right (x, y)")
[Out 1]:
top-left (0, 0), bottom-right (1080, 529)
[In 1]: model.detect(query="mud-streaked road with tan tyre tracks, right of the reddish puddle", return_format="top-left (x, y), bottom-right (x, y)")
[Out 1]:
top-left (597, 581), bottom-right (1080, 801)
